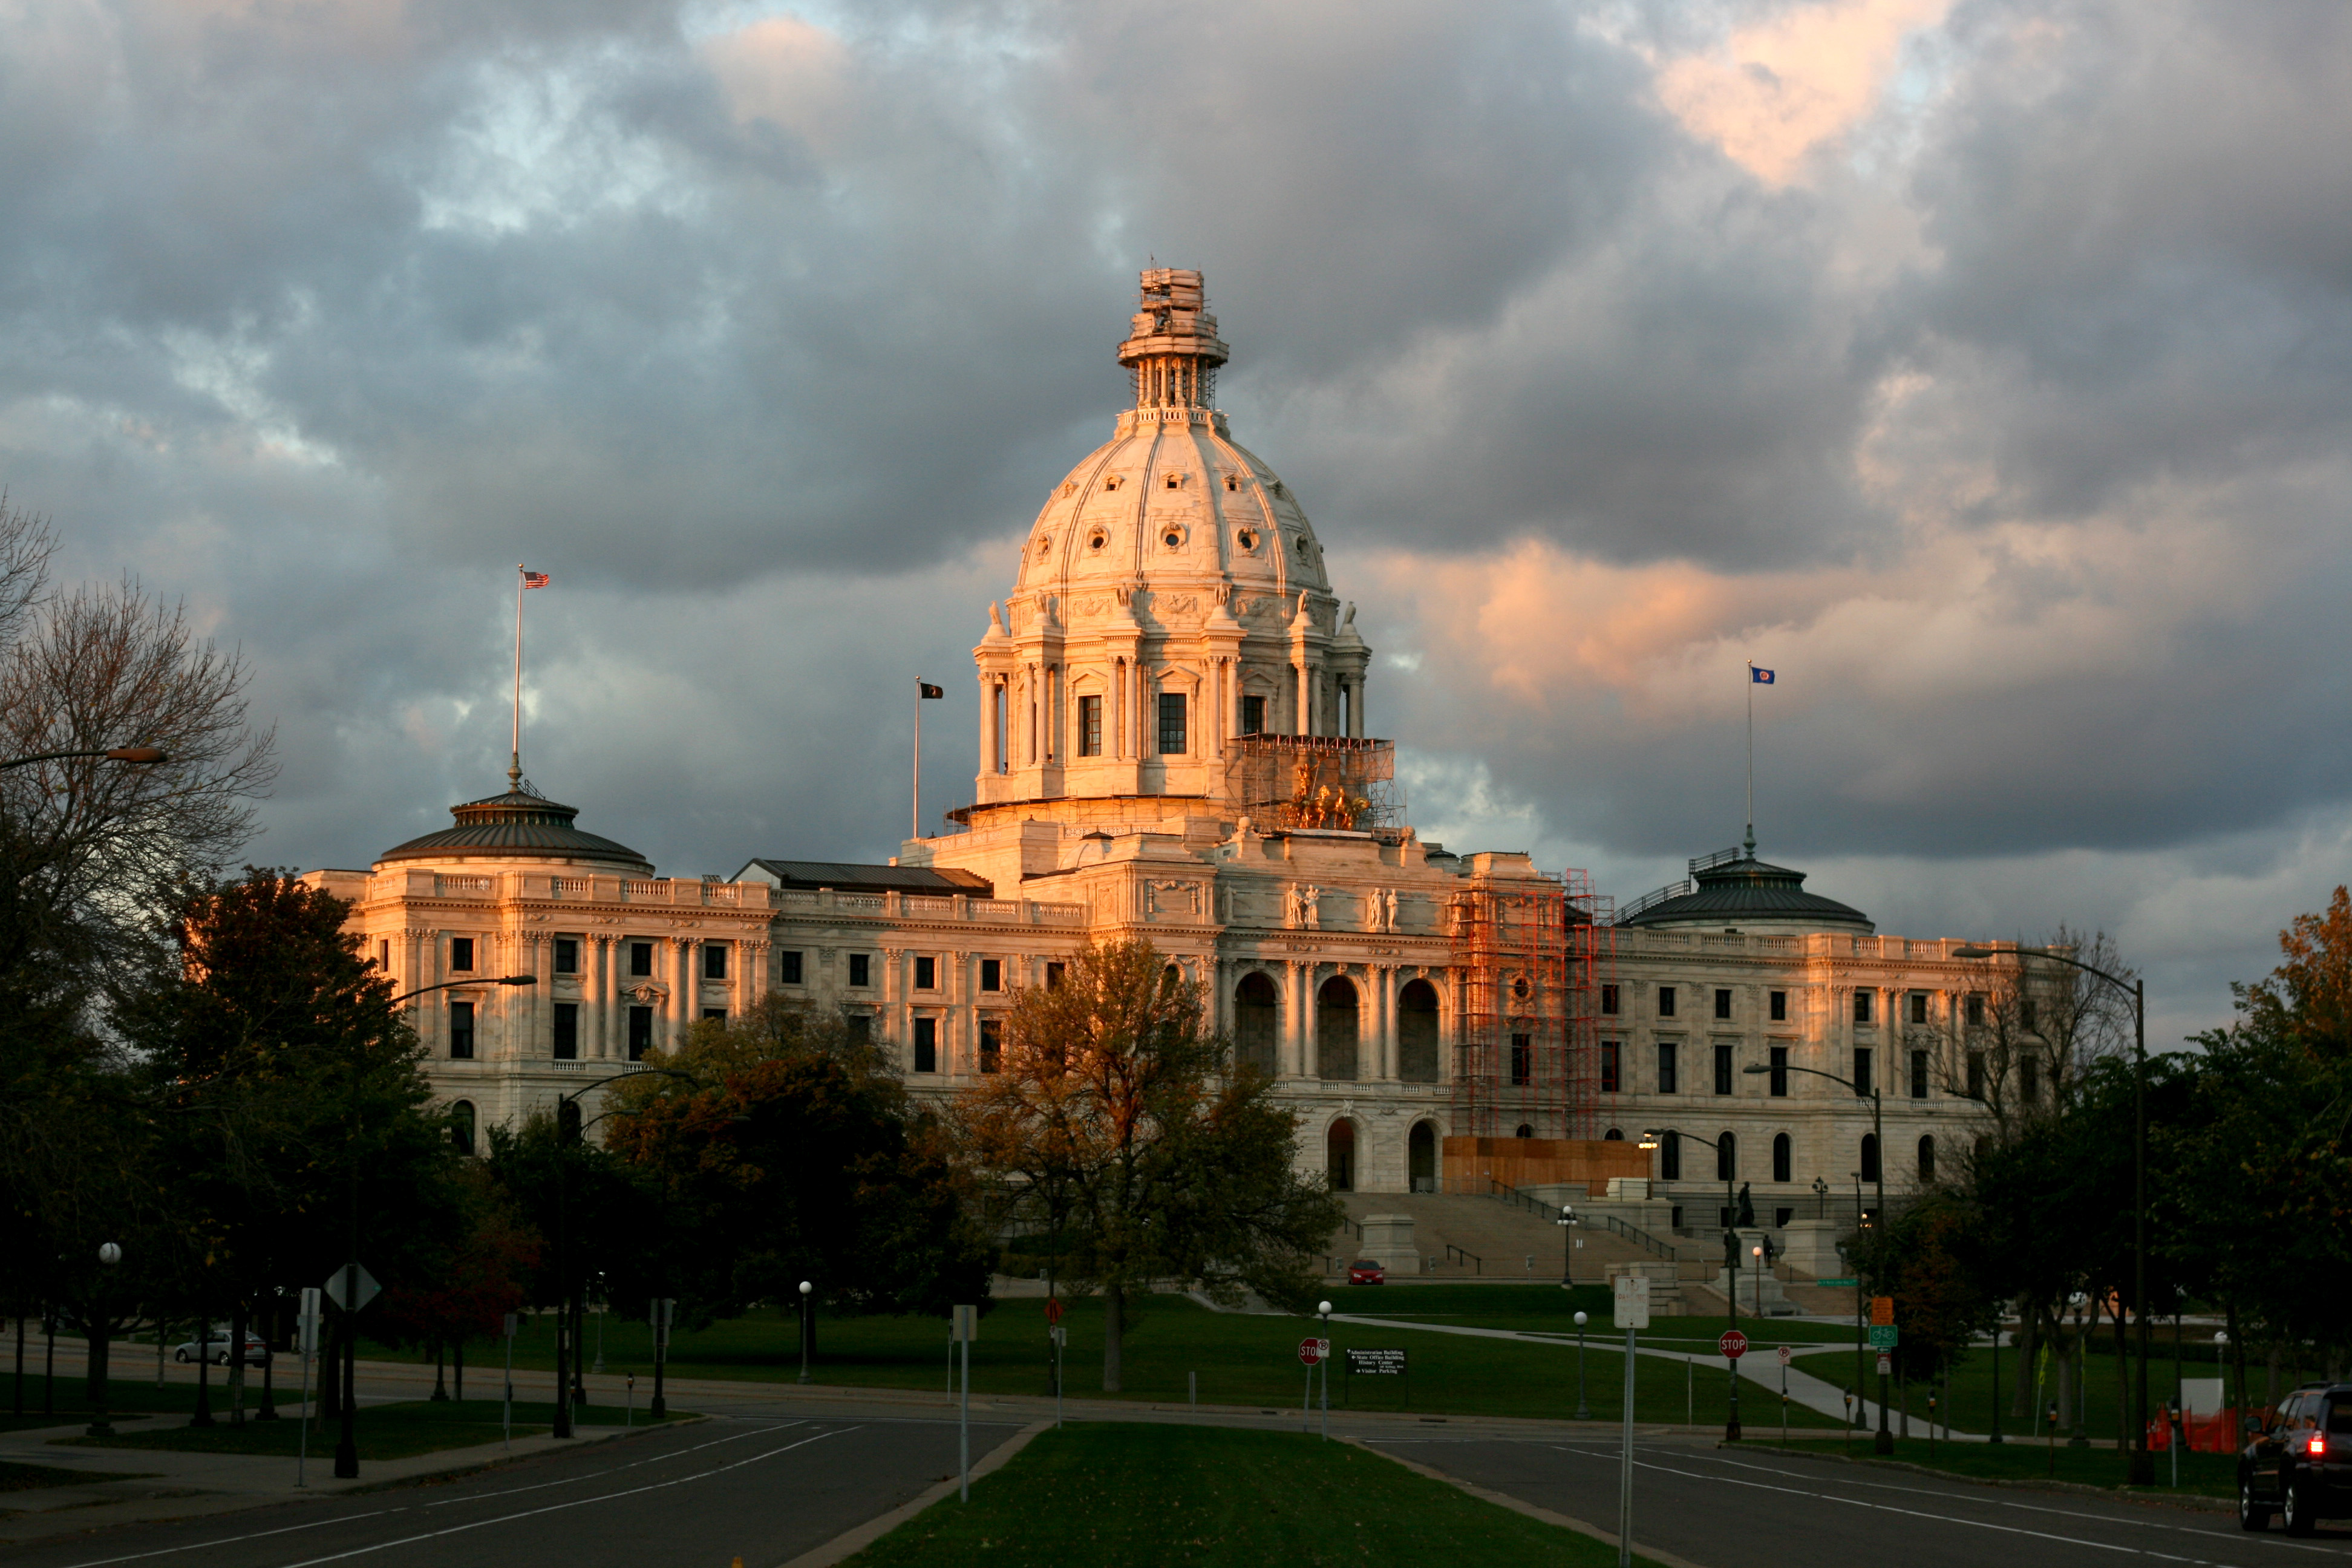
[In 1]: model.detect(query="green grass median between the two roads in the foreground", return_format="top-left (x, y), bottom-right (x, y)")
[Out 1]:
top-left (849, 1425), bottom-right (1648, 1568)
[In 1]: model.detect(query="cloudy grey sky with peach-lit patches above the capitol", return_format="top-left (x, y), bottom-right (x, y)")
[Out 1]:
top-left (0, 0), bottom-right (2352, 1042)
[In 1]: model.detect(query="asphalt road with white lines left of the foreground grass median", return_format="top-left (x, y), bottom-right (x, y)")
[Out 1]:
top-left (0, 1408), bottom-right (1021, 1568)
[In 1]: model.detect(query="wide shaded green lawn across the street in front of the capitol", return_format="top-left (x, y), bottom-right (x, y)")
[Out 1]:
top-left (419, 1286), bottom-right (1835, 1427)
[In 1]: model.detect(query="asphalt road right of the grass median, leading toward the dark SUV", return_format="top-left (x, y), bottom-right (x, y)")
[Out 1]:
top-left (1371, 1436), bottom-right (2352, 1568)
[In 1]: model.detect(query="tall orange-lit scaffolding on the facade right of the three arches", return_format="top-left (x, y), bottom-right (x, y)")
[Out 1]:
top-left (1449, 870), bottom-right (1616, 1166)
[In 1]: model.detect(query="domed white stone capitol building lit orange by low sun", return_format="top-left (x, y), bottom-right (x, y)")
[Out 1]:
top-left (310, 268), bottom-right (2022, 1229)
